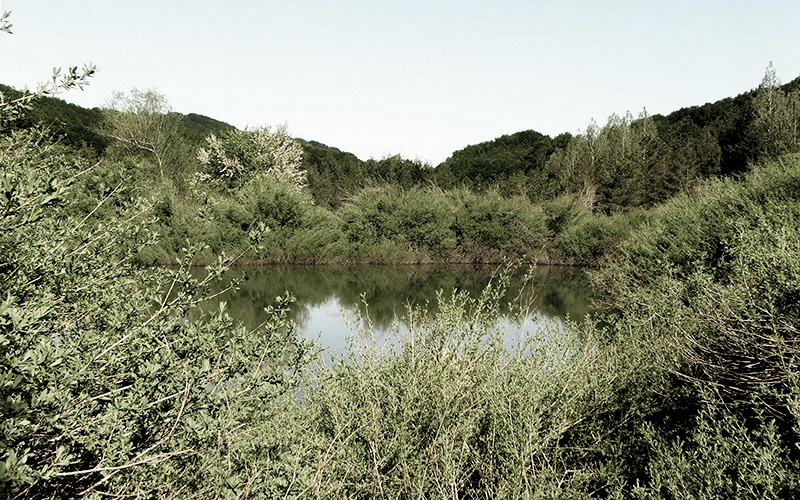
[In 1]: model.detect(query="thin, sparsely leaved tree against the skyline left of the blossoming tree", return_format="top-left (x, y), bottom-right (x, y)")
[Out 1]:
top-left (105, 88), bottom-right (182, 177)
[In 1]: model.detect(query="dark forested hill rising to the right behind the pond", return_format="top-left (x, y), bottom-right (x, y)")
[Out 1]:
top-left (435, 72), bottom-right (800, 211)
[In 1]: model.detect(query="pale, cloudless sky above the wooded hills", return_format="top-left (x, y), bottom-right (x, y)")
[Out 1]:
top-left (0, 0), bottom-right (800, 166)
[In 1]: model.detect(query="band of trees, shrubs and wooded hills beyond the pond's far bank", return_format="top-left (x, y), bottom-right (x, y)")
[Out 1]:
top-left (6, 67), bottom-right (800, 265)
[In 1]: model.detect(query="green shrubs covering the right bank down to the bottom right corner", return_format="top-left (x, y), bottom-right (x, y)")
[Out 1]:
top-left (597, 155), bottom-right (800, 498)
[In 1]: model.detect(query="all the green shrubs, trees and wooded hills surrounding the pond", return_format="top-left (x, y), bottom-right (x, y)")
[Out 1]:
top-left (0, 15), bottom-right (800, 498)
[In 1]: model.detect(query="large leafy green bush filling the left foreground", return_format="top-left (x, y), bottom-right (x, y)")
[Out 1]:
top-left (0, 130), bottom-right (306, 498)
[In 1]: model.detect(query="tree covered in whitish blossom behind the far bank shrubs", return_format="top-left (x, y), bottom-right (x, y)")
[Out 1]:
top-left (197, 125), bottom-right (306, 192)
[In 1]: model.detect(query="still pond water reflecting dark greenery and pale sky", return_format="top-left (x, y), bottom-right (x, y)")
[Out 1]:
top-left (194, 265), bottom-right (591, 354)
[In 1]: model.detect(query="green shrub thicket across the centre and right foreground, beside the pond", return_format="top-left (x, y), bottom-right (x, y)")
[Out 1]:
top-left (244, 156), bottom-right (800, 498)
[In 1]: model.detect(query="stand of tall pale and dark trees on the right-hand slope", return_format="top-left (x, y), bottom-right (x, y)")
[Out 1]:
top-left (537, 66), bottom-right (800, 213)
